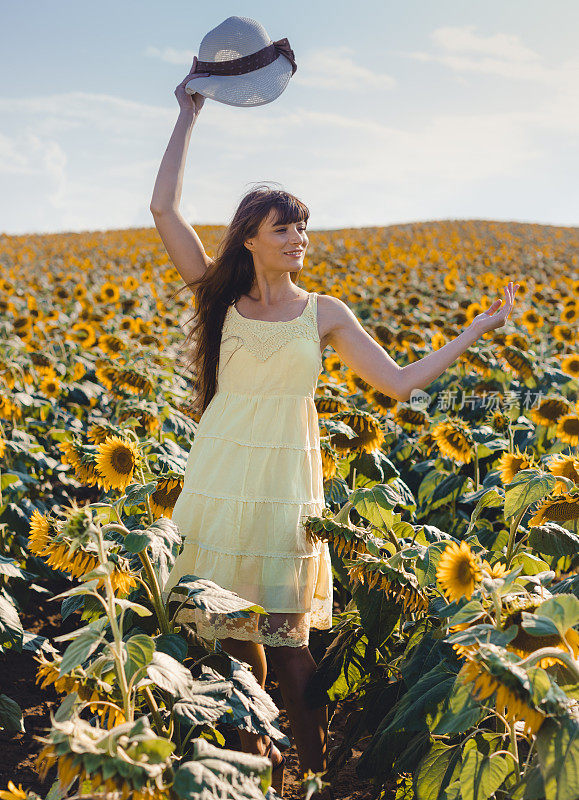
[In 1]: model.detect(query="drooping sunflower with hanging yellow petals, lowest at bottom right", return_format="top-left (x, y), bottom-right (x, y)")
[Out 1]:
top-left (457, 644), bottom-right (545, 735)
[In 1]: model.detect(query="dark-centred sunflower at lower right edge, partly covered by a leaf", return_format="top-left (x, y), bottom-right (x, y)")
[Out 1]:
top-left (501, 595), bottom-right (579, 669)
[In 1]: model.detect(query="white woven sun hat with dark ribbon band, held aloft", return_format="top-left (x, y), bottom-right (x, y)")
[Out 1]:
top-left (185, 17), bottom-right (297, 106)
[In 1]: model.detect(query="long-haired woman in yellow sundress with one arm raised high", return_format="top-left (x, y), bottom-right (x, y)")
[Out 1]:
top-left (150, 59), bottom-right (518, 788)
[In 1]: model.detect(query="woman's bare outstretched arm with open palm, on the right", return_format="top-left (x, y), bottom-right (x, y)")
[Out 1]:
top-left (328, 281), bottom-right (519, 402)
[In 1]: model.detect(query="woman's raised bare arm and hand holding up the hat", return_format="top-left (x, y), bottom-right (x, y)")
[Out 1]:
top-left (150, 56), bottom-right (211, 283)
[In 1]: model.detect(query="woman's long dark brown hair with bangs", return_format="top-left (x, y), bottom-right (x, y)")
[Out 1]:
top-left (174, 183), bottom-right (310, 415)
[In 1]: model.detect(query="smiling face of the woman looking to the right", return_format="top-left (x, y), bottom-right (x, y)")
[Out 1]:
top-left (245, 209), bottom-right (309, 272)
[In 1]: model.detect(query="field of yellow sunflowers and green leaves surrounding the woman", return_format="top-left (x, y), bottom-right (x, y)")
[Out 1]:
top-left (0, 221), bottom-right (579, 800)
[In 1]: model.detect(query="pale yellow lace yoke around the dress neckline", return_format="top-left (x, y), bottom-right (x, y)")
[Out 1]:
top-left (222, 293), bottom-right (322, 363)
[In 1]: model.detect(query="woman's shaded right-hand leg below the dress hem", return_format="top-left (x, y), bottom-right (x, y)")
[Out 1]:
top-left (267, 645), bottom-right (328, 773)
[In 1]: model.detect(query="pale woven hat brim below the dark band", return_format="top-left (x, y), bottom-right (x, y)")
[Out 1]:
top-left (185, 55), bottom-right (292, 107)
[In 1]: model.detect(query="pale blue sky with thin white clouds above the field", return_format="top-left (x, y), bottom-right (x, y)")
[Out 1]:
top-left (0, 0), bottom-right (579, 234)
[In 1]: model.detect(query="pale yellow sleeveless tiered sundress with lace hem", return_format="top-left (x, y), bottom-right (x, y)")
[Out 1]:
top-left (163, 292), bottom-right (332, 647)
